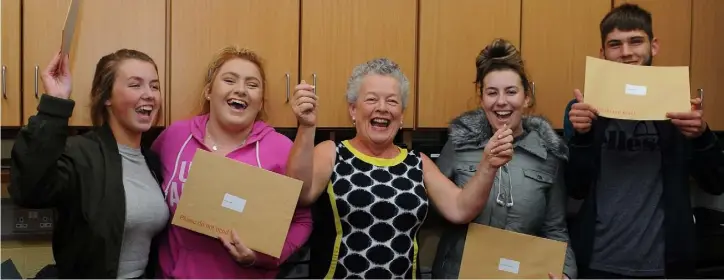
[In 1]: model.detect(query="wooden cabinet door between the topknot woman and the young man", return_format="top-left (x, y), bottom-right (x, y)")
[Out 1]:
top-left (521, 0), bottom-right (611, 129)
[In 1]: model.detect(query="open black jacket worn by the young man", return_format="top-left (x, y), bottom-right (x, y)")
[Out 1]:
top-left (566, 117), bottom-right (724, 278)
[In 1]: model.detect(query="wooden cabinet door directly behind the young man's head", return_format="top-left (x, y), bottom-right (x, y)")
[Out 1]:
top-left (614, 0), bottom-right (699, 66)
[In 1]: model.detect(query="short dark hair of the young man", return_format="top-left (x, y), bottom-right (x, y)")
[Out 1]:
top-left (600, 3), bottom-right (654, 46)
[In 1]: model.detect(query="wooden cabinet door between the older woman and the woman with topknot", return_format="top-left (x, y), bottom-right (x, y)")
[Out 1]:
top-left (417, 0), bottom-right (521, 128)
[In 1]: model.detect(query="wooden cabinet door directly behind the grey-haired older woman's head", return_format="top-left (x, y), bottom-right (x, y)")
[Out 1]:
top-left (301, 0), bottom-right (417, 128)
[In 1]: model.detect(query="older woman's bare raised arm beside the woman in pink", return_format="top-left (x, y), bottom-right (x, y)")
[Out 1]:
top-left (286, 81), bottom-right (336, 207)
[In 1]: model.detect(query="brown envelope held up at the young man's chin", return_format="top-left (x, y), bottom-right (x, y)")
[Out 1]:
top-left (583, 56), bottom-right (691, 120)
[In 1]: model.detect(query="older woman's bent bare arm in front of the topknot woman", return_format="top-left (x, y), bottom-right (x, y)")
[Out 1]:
top-left (421, 123), bottom-right (513, 224)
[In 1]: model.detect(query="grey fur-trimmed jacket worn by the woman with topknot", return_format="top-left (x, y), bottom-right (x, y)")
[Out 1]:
top-left (432, 109), bottom-right (577, 279)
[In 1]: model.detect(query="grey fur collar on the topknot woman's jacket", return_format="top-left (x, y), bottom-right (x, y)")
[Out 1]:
top-left (449, 109), bottom-right (568, 160)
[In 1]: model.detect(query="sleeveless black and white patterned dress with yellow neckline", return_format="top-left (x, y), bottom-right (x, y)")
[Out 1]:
top-left (310, 141), bottom-right (429, 279)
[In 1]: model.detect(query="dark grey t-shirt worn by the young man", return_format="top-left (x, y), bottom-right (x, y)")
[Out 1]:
top-left (589, 120), bottom-right (664, 277)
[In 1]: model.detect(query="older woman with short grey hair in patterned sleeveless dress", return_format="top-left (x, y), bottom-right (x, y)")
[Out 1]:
top-left (287, 58), bottom-right (513, 279)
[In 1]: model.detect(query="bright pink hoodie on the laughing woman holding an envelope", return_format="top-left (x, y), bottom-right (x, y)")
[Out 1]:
top-left (152, 115), bottom-right (312, 279)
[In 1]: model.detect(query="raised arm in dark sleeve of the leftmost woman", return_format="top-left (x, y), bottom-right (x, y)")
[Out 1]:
top-left (8, 54), bottom-right (75, 208)
